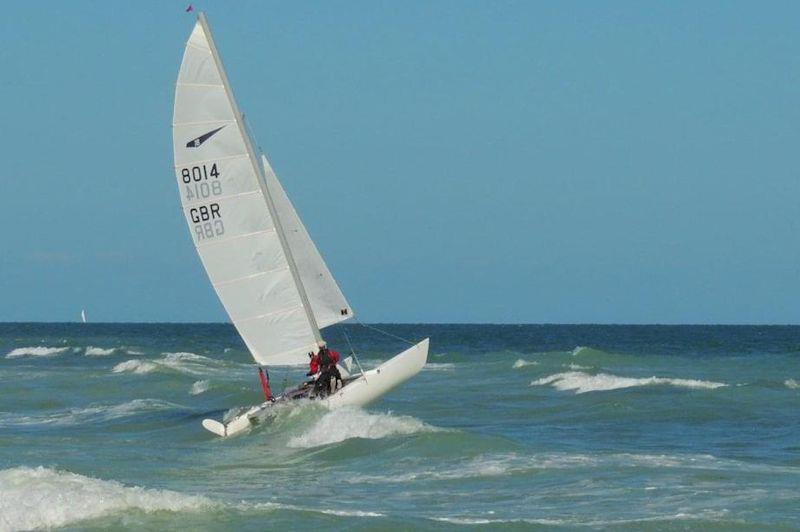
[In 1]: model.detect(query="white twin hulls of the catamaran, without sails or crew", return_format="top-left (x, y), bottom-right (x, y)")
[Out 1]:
top-left (203, 338), bottom-right (428, 437)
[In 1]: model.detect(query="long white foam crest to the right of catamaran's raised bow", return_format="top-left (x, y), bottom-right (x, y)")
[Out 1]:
top-left (531, 371), bottom-right (727, 393)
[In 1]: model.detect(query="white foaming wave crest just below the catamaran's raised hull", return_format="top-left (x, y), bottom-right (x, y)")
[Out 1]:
top-left (288, 408), bottom-right (442, 448)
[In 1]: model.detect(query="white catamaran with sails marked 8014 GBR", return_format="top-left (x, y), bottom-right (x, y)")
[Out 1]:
top-left (172, 12), bottom-right (428, 436)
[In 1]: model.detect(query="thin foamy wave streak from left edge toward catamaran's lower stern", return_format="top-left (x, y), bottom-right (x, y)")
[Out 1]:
top-left (0, 399), bottom-right (182, 427)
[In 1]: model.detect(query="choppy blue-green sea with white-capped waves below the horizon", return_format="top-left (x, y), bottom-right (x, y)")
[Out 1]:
top-left (0, 323), bottom-right (800, 531)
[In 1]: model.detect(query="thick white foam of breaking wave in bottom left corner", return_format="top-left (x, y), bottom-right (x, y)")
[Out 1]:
top-left (0, 467), bottom-right (217, 530)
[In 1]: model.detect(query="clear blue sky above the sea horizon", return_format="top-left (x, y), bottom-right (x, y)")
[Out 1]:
top-left (0, 0), bottom-right (800, 323)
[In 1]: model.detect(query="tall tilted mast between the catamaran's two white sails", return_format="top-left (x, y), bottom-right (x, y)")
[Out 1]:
top-left (197, 11), bottom-right (322, 345)
